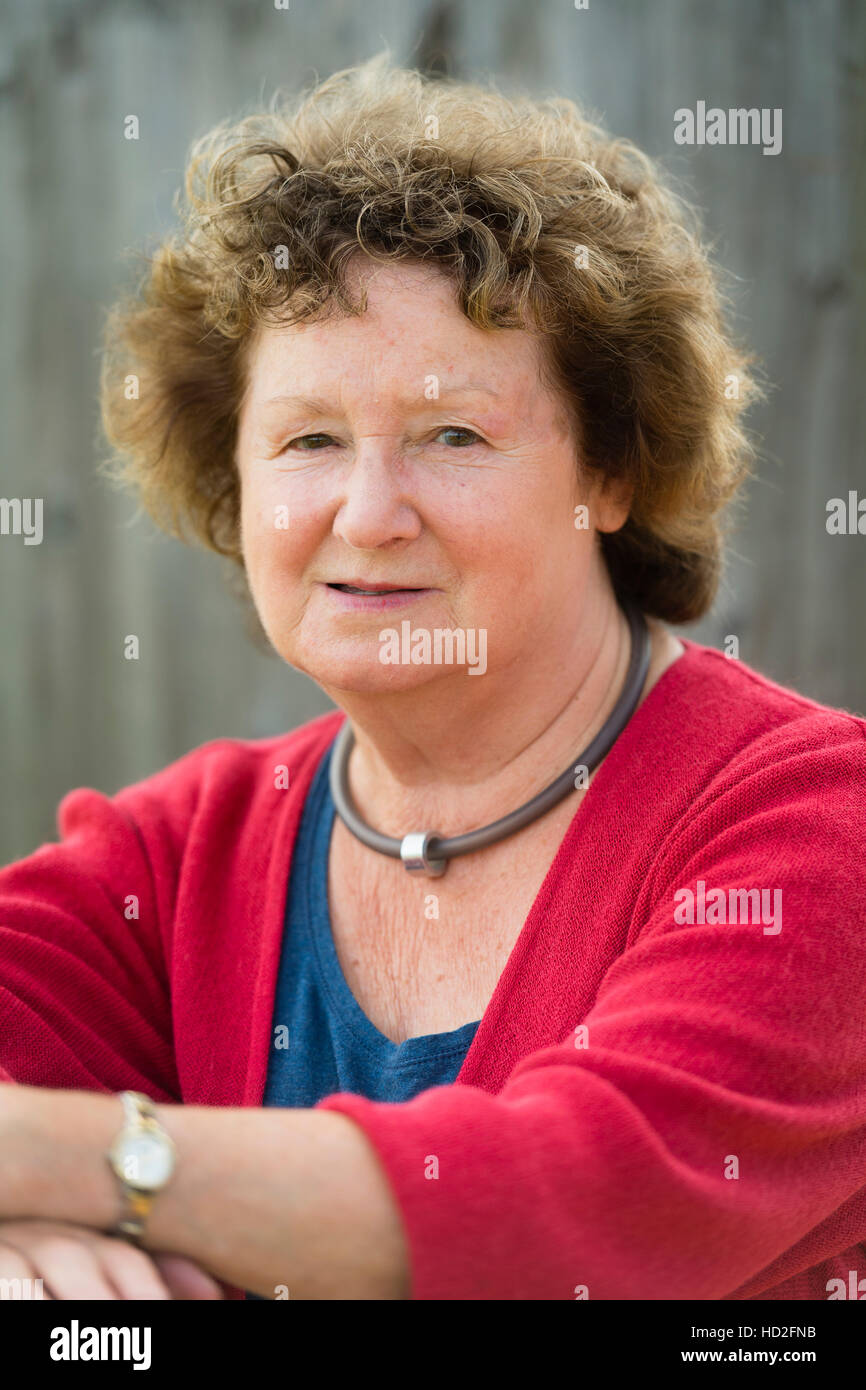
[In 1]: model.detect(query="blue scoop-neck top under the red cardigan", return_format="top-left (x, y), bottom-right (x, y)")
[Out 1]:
top-left (263, 744), bottom-right (481, 1106)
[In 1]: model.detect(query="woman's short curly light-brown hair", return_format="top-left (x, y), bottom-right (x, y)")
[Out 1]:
top-left (101, 51), bottom-right (763, 623)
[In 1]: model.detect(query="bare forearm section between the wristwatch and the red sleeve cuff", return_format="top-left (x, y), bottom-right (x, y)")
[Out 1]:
top-left (150, 1106), bottom-right (409, 1298)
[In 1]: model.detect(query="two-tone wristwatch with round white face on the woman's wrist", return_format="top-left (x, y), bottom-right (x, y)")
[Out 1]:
top-left (106, 1091), bottom-right (175, 1245)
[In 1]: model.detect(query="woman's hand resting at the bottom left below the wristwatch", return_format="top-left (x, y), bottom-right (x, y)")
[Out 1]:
top-left (0, 1220), bottom-right (222, 1301)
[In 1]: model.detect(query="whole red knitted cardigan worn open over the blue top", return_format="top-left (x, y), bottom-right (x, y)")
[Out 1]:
top-left (0, 641), bottom-right (866, 1300)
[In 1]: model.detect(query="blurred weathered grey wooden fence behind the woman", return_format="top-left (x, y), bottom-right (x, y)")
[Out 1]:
top-left (0, 0), bottom-right (866, 860)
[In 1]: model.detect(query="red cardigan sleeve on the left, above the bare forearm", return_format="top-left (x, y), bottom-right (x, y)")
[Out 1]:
top-left (0, 788), bottom-right (179, 1101)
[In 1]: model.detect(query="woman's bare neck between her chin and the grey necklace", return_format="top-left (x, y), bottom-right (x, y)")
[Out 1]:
top-left (323, 599), bottom-right (684, 835)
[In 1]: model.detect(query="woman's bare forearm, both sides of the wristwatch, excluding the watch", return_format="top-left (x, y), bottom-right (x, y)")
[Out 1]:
top-left (0, 1087), bottom-right (409, 1298)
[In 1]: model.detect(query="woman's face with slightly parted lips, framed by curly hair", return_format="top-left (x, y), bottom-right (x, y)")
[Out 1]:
top-left (236, 259), bottom-right (627, 696)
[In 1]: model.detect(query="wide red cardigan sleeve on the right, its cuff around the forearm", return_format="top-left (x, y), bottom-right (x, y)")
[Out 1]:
top-left (318, 720), bottom-right (866, 1300)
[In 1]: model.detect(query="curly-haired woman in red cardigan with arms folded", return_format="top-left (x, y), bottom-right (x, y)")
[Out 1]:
top-left (0, 58), bottom-right (866, 1300)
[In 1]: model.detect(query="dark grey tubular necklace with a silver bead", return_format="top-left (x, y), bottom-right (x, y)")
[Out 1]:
top-left (329, 603), bottom-right (651, 878)
